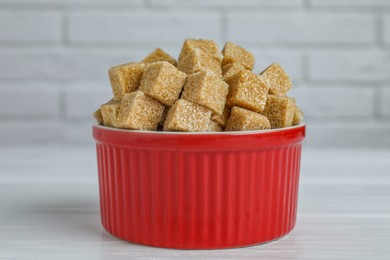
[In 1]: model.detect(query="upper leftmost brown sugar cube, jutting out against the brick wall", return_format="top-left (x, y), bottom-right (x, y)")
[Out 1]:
top-left (108, 62), bottom-right (145, 100)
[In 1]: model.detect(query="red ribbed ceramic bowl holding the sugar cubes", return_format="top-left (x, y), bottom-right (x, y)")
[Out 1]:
top-left (93, 125), bottom-right (305, 249)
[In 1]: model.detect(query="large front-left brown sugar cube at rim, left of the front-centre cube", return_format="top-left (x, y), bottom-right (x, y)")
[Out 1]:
top-left (115, 90), bottom-right (164, 130)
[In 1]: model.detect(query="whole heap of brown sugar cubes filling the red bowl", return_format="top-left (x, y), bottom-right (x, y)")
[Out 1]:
top-left (94, 39), bottom-right (303, 132)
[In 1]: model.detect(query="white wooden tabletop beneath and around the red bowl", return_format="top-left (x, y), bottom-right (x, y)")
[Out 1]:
top-left (0, 146), bottom-right (390, 259)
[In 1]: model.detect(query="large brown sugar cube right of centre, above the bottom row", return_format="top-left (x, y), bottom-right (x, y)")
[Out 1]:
top-left (226, 70), bottom-right (268, 112)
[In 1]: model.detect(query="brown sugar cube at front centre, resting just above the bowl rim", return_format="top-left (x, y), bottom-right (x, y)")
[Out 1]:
top-left (164, 99), bottom-right (211, 132)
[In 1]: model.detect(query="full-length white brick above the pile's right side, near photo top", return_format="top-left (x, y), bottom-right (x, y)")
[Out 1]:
top-left (227, 13), bottom-right (375, 45)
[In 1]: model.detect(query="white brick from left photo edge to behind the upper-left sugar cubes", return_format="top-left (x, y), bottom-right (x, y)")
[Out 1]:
top-left (0, 48), bottom-right (146, 81)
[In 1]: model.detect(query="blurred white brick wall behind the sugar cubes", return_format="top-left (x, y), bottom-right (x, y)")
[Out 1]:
top-left (0, 0), bottom-right (390, 148)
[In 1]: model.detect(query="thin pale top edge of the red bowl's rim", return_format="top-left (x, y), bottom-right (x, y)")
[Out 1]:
top-left (93, 122), bottom-right (306, 135)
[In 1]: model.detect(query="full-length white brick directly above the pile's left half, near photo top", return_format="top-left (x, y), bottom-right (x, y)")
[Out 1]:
top-left (67, 12), bottom-right (220, 43)
